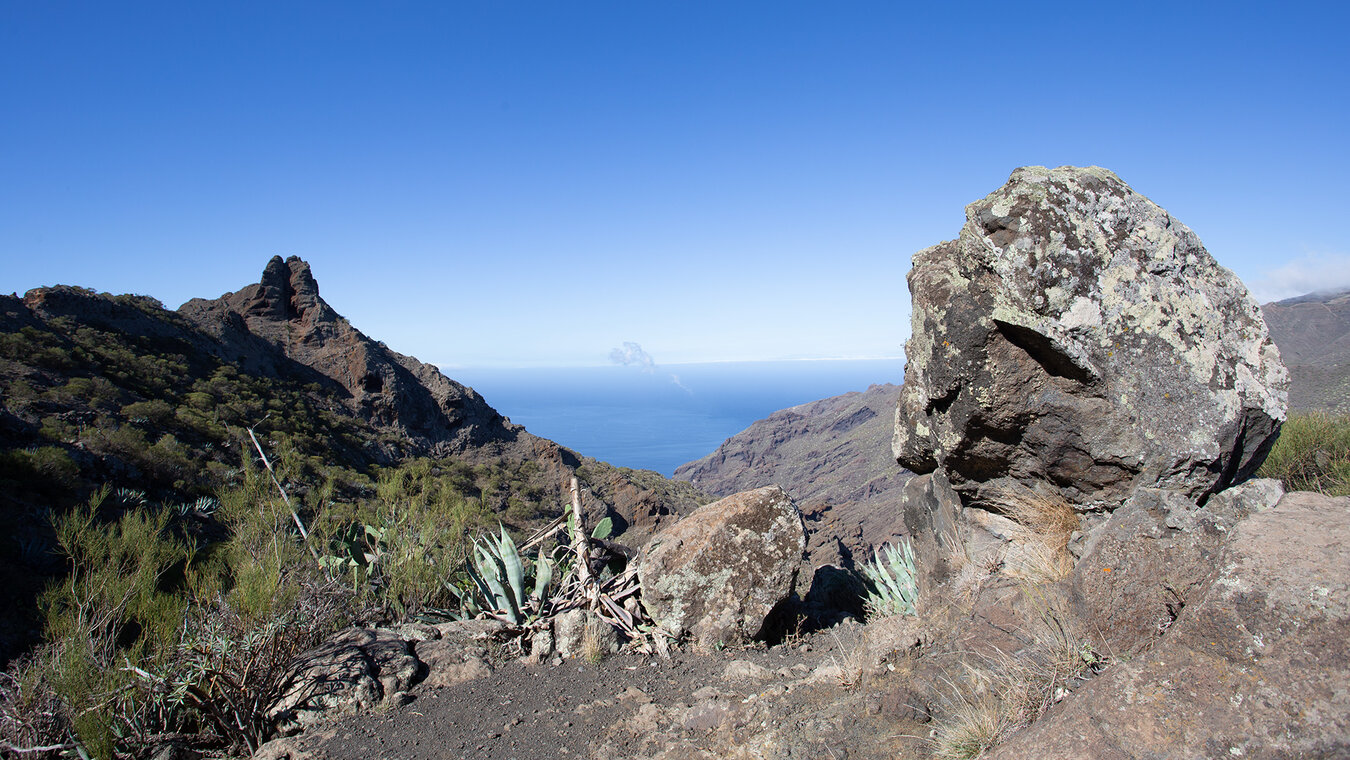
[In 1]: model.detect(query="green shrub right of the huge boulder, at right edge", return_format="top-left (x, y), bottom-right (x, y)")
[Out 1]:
top-left (1257, 412), bottom-right (1350, 495)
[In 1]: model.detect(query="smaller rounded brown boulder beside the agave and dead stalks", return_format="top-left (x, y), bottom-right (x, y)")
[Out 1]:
top-left (637, 486), bottom-right (806, 648)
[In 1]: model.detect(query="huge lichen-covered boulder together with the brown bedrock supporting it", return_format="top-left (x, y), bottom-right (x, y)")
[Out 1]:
top-left (894, 167), bottom-right (1350, 760)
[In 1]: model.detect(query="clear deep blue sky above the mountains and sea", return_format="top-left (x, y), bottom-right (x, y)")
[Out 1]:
top-left (0, 0), bottom-right (1350, 367)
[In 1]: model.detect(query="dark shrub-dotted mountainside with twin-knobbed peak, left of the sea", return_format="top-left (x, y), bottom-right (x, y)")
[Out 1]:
top-left (0, 256), bottom-right (709, 656)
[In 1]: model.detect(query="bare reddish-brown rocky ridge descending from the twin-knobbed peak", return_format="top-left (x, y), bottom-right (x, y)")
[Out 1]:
top-left (178, 256), bottom-right (701, 544)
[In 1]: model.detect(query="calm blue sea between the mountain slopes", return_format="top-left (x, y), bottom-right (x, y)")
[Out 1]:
top-left (446, 359), bottom-right (905, 475)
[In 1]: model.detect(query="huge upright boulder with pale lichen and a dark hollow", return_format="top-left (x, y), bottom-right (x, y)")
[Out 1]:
top-left (892, 166), bottom-right (1288, 508)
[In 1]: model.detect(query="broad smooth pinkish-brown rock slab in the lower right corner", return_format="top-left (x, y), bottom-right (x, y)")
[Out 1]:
top-left (992, 493), bottom-right (1350, 760)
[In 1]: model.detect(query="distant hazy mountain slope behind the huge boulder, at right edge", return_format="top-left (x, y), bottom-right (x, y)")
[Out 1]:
top-left (1261, 290), bottom-right (1350, 413)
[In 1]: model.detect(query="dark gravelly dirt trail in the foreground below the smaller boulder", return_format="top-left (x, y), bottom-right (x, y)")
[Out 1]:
top-left (259, 625), bottom-right (939, 760)
